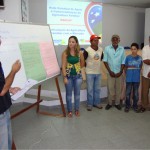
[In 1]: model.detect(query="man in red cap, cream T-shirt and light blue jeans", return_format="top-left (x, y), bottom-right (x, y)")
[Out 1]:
top-left (84, 35), bottom-right (103, 111)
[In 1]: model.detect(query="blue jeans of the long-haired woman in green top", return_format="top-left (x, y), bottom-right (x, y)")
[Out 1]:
top-left (65, 75), bottom-right (82, 112)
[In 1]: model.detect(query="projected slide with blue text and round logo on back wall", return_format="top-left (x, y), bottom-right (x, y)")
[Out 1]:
top-left (47, 0), bottom-right (102, 45)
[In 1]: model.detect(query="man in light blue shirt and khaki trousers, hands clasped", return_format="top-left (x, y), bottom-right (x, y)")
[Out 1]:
top-left (103, 35), bottom-right (125, 110)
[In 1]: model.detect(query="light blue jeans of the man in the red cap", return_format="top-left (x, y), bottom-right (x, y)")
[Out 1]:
top-left (86, 74), bottom-right (101, 106)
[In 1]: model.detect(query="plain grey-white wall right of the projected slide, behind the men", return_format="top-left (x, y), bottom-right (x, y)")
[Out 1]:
top-left (103, 5), bottom-right (145, 46)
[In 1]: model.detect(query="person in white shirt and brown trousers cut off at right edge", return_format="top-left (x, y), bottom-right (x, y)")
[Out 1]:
top-left (138, 36), bottom-right (150, 112)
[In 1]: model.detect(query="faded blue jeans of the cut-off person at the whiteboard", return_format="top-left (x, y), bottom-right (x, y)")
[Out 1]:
top-left (0, 110), bottom-right (12, 150)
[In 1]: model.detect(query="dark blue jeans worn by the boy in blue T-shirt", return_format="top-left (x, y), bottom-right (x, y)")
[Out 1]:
top-left (126, 82), bottom-right (140, 109)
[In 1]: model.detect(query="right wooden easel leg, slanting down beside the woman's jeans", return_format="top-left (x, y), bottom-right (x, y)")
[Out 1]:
top-left (55, 77), bottom-right (66, 117)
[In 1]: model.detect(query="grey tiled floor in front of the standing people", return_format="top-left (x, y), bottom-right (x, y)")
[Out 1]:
top-left (11, 103), bottom-right (150, 149)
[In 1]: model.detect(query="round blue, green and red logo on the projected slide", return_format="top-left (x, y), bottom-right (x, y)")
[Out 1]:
top-left (84, 2), bottom-right (102, 36)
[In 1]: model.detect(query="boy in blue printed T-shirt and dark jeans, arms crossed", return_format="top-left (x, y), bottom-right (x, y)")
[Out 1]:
top-left (124, 43), bottom-right (142, 112)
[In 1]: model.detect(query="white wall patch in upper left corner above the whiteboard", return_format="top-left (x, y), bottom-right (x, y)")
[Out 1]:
top-left (0, 0), bottom-right (21, 22)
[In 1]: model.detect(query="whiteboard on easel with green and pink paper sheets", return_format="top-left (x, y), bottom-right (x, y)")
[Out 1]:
top-left (0, 22), bottom-right (60, 88)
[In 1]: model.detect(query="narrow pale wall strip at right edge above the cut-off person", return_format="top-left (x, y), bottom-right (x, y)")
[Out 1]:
top-left (144, 8), bottom-right (150, 45)
